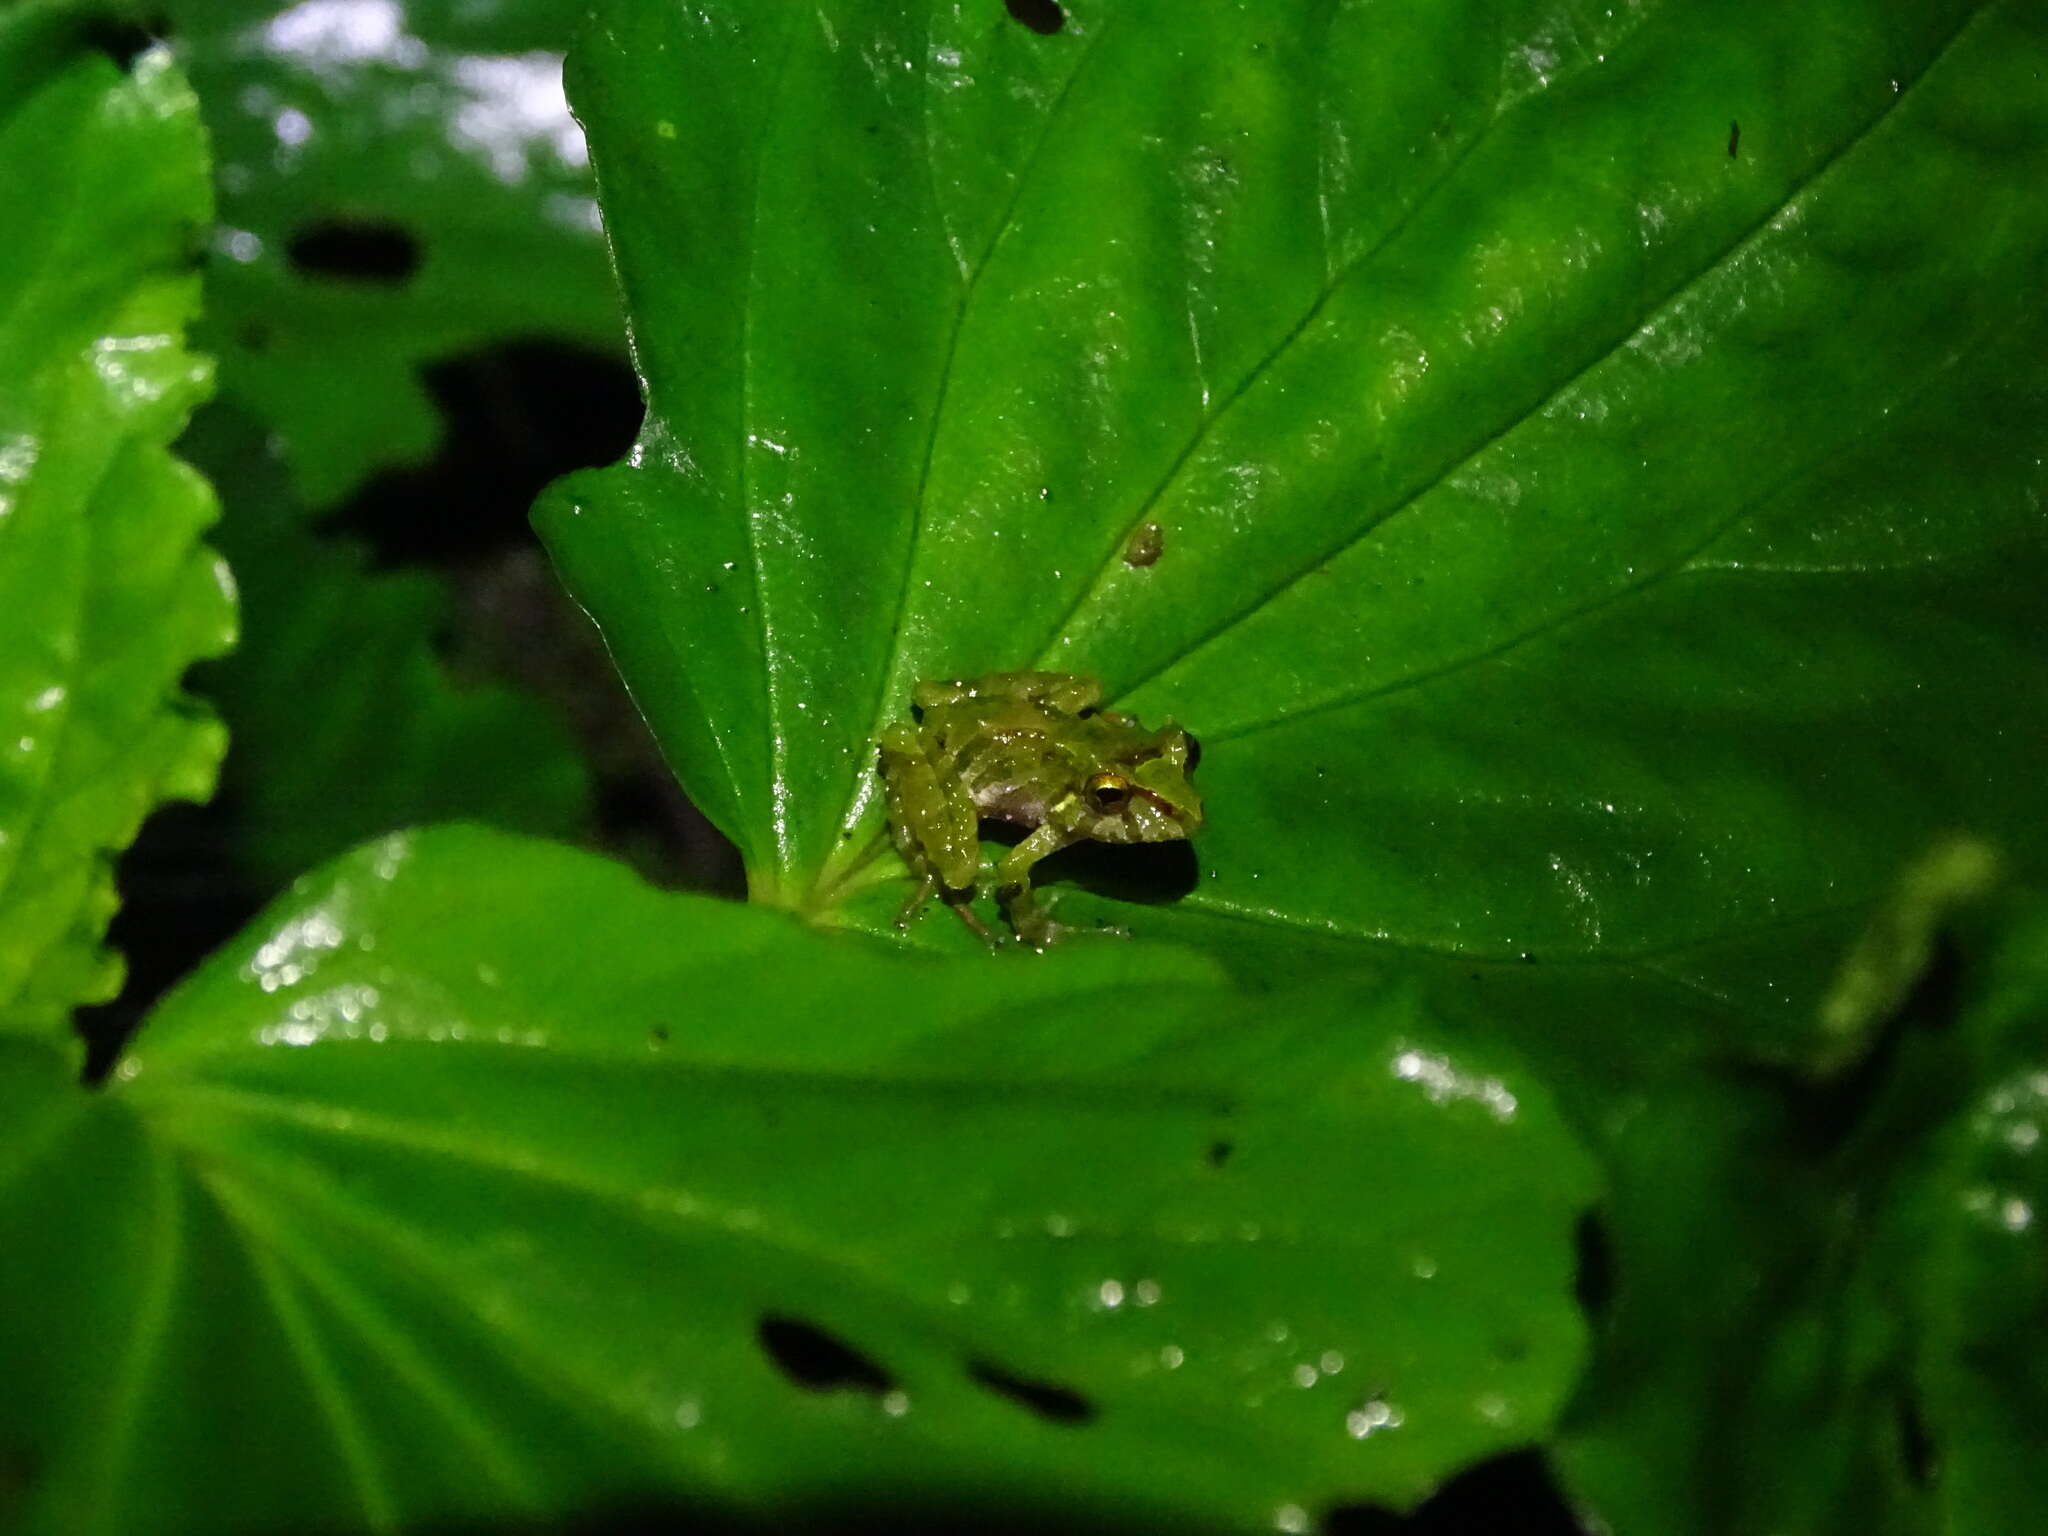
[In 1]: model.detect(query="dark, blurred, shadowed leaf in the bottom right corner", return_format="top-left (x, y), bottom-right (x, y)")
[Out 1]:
top-left (1559, 848), bottom-right (2048, 1536)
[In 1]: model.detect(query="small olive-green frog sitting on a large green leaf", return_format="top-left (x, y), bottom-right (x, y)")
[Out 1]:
top-left (881, 672), bottom-right (1202, 946)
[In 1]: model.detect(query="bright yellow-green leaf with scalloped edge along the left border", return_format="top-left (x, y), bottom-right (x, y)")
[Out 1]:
top-left (0, 4), bottom-right (233, 1034)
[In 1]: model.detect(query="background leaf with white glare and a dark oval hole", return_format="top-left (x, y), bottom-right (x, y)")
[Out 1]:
top-left (162, 0), bottom-right (623, 506)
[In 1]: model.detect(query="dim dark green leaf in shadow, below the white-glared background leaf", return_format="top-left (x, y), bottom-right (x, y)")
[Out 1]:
top-left (180, 406), bottom-right (590, 889)
